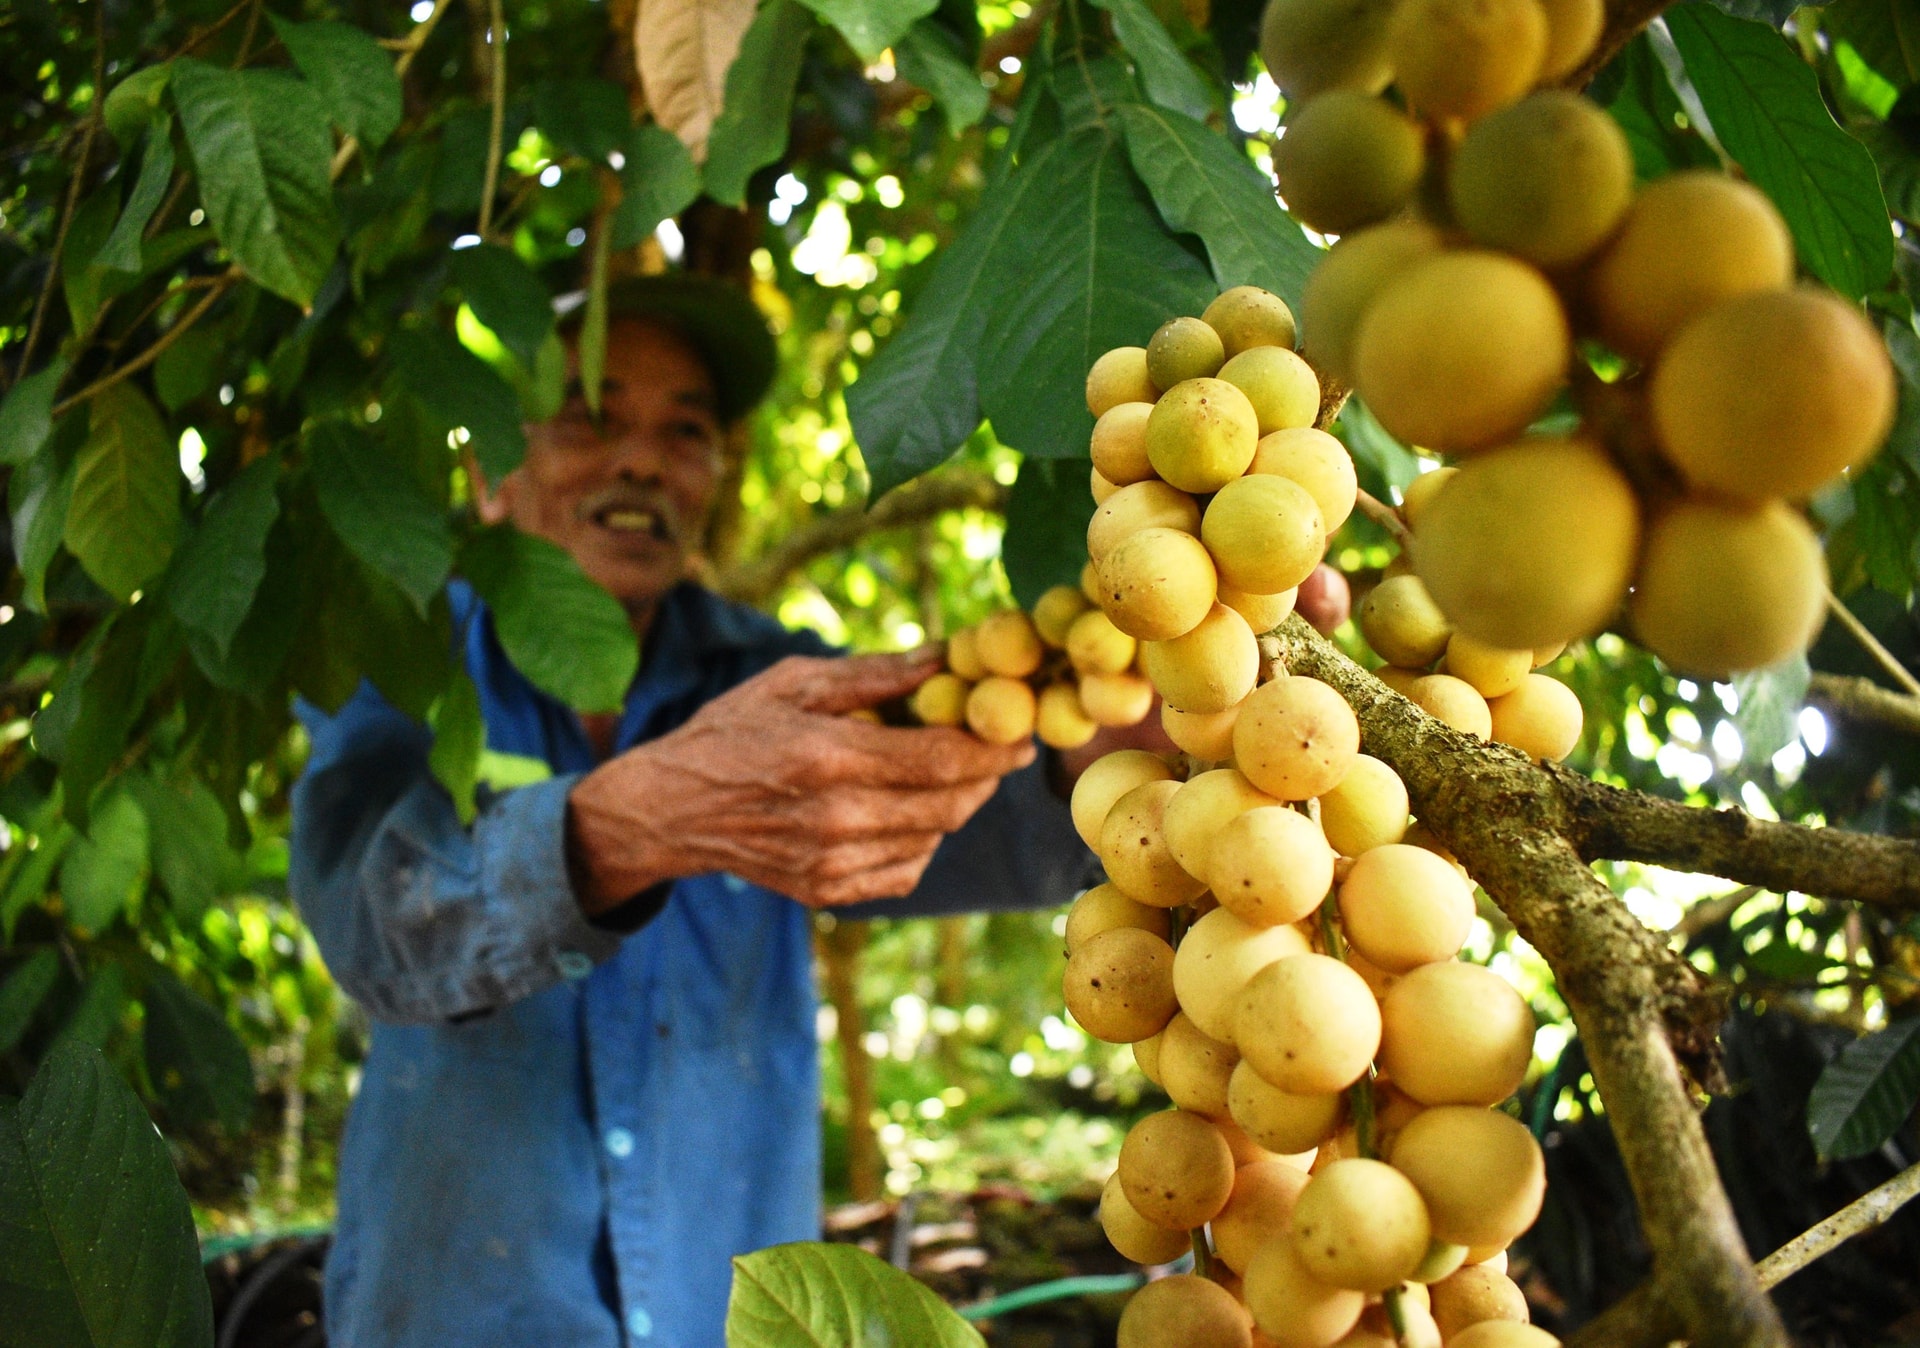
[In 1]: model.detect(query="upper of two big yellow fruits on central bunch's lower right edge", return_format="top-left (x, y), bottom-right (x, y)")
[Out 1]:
top-left (1382, 960), bottom-right (1534, 1106)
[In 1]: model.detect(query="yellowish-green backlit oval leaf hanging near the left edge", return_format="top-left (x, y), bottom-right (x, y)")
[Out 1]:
top-left (67, 382), bottom-right (180, 601)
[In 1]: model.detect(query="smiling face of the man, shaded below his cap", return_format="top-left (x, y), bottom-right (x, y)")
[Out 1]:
top-left (480, 319), bottom-right (722, 616)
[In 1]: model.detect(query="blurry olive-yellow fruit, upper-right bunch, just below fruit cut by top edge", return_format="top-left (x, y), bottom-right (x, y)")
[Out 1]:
top-left (1448, 88), bottom-right (1634, 267)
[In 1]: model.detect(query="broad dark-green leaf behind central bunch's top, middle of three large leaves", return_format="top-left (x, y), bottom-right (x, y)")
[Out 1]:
top-left (977, 129), bottom-right (1215, 459)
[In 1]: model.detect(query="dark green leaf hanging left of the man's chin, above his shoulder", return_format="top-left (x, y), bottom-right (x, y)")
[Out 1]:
top-left (307, 421), bottom-right (453, 614)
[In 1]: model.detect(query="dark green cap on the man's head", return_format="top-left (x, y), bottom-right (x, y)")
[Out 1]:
top-left (555, 271), bottom-right (780, 421)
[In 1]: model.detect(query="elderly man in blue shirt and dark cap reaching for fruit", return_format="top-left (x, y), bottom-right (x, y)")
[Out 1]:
top-left (290, 278), bottom-right (1091, 1348)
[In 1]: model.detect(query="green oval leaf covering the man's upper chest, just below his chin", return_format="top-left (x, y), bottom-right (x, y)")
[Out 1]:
top-left (461, 526), bottom-right (639, 712)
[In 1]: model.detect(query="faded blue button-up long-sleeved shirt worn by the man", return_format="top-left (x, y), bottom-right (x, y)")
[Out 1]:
top-left (290, 586), bottom-right (1091, 1348)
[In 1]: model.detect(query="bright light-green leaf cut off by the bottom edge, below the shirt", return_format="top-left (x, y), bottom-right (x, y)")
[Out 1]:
top-left (726, 1240), bottom-right (985, 1348)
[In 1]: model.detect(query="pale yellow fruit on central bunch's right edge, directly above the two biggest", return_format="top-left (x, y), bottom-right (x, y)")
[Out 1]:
top-left (1340, 843), bottom-right (1473, 974)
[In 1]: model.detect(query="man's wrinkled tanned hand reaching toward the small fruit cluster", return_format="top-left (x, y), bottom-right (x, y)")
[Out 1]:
top-left (568, 651), bottom-right (1035, 912)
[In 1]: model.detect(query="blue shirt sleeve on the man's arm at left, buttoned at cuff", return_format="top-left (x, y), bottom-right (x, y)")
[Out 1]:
top-left (288, 686), bottom-right (622, 1022)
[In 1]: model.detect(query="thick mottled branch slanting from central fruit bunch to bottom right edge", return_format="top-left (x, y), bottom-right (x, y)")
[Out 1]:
top-left (1279, 614), bottom-right (1788, 1348)
